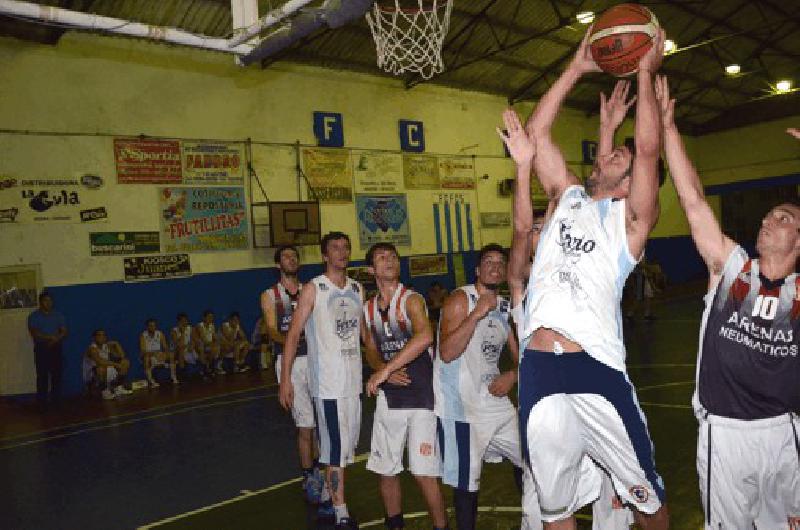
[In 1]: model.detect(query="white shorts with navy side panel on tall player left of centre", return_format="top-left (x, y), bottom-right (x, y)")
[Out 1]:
top-left (313, 396), bottom-right (361, 467)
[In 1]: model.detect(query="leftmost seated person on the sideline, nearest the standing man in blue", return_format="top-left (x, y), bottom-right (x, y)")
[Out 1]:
top-left (84, 329), bottom-right (132, 399)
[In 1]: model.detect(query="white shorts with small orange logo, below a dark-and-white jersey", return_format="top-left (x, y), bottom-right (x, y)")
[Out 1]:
top-left (367, 392), bottom-right (442, 477)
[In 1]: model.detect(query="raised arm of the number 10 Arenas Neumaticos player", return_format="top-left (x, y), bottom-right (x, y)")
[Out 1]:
top-left (656, 76), bottom-right (735, 285)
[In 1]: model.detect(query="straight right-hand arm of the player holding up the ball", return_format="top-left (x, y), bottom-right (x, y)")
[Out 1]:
top-left (626, 29), bottom-right (664, 257)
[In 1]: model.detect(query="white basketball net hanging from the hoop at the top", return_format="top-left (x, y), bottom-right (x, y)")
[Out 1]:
top-left (367, 0), bottom-right (453, 79)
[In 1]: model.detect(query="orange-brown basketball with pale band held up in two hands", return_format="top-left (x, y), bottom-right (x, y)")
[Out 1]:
top-left (589, 4), bottom-right (658, 77)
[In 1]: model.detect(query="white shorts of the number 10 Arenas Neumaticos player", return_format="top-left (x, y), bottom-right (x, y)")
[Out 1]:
top-left (697, 408), bottom-right (800, 530)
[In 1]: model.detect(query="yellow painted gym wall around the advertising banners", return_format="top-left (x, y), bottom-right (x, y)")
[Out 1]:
top-left (0, 32), bottom-right (800, 393)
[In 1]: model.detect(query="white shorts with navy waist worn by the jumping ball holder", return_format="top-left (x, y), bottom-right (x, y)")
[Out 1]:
top-left (519, 350), bottom-right (664, 522)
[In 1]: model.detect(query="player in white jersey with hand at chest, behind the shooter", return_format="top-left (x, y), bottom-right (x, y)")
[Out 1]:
top-left (433, 244), bottom-right (522, 530)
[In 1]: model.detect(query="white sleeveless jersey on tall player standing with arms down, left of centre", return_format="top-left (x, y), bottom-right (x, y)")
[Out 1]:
top-left (305, 274), bottom-right (363, 399)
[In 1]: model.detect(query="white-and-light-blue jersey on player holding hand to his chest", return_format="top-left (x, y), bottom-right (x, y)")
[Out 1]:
top-left (433, 285), bottom-right (514, 423)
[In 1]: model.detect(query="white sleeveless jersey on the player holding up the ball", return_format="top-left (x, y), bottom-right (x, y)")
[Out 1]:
top-left (521, 185), bottom-right (637, 371)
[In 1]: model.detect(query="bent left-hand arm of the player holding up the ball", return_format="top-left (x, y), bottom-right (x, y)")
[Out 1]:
top-left (525, 27), bottom-right (600, 199)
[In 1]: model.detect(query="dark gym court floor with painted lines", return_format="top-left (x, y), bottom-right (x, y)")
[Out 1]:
top-left (0, 297), bottom-right (702, 530)
